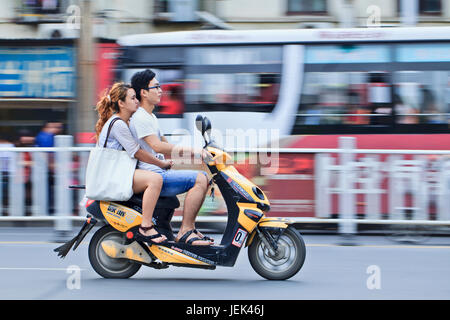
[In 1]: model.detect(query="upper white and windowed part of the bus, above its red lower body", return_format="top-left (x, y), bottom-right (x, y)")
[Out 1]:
top-left (118, 27), bottom-right (450, 148)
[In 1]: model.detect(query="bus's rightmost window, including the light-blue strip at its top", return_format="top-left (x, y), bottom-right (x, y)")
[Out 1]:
top-left (394, 42), bottom-right (450, 127)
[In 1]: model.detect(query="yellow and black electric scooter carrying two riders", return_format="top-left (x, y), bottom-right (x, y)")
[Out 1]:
top-left (55, 116), bottom-right (306, 280)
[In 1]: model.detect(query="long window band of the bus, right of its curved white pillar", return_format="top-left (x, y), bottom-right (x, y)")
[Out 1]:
top-left (293, 42), bottom-right (450, 134)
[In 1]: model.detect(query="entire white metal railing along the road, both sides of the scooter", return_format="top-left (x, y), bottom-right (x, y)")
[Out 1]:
top-left (0, 136), bottom-right (450, 234)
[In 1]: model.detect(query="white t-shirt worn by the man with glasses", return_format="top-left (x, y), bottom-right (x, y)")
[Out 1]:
top-left (130, 107), bottom-right (164, 171)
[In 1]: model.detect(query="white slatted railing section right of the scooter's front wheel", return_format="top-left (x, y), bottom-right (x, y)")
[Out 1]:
top-left (316, 138), bottom-right (450, 233)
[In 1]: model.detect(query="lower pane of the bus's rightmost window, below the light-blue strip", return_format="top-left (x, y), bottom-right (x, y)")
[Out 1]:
top-left (394, 71), bottom-right (450, 124)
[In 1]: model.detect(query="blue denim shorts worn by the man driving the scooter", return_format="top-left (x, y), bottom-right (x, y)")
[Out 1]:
top-left (156, 170), bottom-right (208, 197)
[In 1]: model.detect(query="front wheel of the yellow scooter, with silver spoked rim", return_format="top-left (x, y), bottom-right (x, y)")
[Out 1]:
top-left (248, 226), bottom-right (306, 280)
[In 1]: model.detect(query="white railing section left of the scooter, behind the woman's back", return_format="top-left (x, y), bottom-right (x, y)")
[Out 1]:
top-left (0, 136), bottom-right (91, 231)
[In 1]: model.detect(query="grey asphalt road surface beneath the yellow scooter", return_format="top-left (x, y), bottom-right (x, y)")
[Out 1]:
top-left (0, 228), bottom-right (450, 300)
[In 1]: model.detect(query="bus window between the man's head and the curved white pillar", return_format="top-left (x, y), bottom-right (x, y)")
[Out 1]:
top-left (185, 46), bottom-right (282, 112)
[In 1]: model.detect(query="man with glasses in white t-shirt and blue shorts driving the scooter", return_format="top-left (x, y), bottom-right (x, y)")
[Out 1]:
top-left (130, 69), bottom-right (213, 245)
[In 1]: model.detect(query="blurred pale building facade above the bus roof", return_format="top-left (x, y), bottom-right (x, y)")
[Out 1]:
top-left (0, 0), bottom-right (450, 39)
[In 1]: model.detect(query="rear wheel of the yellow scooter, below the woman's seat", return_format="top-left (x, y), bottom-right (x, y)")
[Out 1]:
top-left (89, 225), bottom-right (141, 279)
